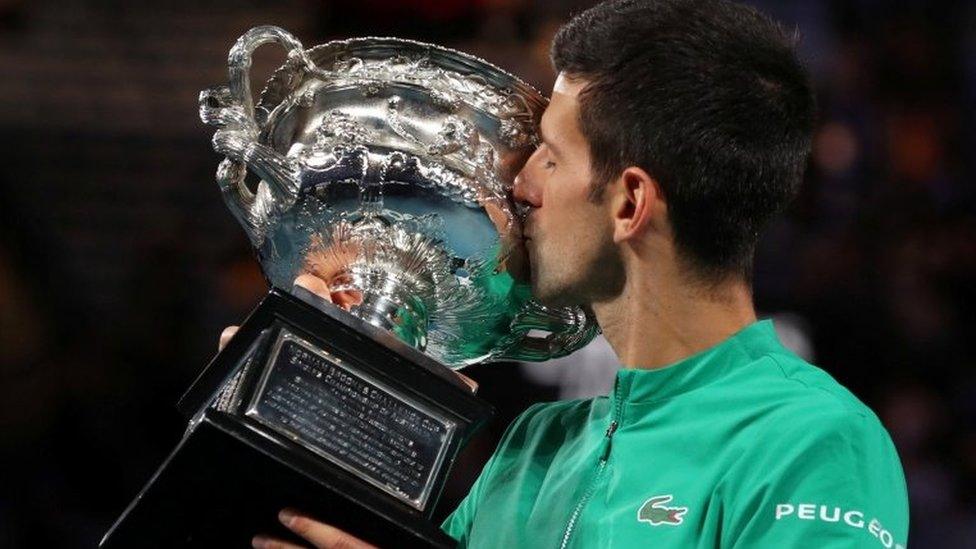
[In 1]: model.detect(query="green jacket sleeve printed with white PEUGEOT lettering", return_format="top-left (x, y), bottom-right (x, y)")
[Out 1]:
top-left (722, 407), bottom-right (908, 549)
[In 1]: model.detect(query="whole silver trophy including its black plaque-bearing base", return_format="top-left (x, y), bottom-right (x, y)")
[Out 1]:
top-left (102, 27), bottom-right (596, 547)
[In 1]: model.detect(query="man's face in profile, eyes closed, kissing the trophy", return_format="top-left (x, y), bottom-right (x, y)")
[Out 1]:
top-left (514, 74), bottom-right (619, 306)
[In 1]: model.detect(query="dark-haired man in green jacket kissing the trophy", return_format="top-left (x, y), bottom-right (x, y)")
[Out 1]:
top-left (244, 0), bottom-right (908, 548)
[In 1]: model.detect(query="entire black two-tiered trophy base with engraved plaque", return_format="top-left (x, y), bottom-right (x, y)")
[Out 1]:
top-left (101, 288), bottom-right (493, 548)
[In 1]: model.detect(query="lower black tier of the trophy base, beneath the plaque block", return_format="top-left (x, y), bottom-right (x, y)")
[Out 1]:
top-left (101, 414), bottom-right (457, 548)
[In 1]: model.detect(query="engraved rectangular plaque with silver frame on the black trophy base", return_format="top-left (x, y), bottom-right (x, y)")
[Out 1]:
top-left (246, 329), bottom-right (456, 510)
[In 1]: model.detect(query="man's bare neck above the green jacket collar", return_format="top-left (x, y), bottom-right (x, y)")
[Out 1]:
top-left (593, 260), bottom-right (756, 369)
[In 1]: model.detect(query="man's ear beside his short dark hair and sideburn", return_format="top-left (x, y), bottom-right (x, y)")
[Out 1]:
top-left (612, 166), bottom-right (667, 242)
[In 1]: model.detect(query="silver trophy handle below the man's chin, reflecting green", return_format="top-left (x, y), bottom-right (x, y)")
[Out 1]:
top-left (498, 301), bottom-right (600, 362)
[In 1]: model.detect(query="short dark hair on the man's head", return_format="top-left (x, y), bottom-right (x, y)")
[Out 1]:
top-left (551, 0), bottom-right (816, 281)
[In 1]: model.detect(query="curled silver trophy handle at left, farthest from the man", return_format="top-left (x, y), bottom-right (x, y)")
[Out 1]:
top-left (200, 25), bottom-right (306, 246)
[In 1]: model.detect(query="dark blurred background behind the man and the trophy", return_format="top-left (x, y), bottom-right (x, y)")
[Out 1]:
top-left (0, 0), bottom-right (976, 547)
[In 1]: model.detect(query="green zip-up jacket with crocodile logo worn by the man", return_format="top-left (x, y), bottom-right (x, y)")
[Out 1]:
top-left (443, 321), bottom-right (908, 548)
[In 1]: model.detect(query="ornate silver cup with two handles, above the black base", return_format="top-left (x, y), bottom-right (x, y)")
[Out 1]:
top-left (200, 26), bottom-right (596, 368)
